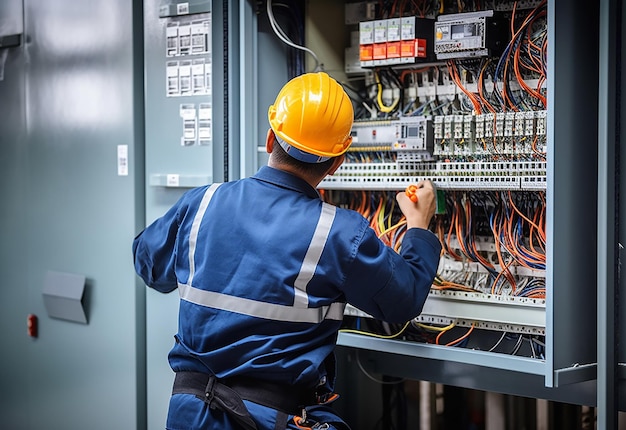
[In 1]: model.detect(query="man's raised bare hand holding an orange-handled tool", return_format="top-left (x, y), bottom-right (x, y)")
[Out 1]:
top-left (396, 181), bottom-right (437, 229)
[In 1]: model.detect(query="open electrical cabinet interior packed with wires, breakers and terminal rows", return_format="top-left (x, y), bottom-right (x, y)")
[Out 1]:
top-left (320, 1), bottom-right (547, 360)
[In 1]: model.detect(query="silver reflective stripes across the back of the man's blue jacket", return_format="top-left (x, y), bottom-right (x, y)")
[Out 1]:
top-left (178, 184), bottom-right (346, 323)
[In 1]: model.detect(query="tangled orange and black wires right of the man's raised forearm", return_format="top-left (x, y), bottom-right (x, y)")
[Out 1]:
top-left (434, 191), bottom-right (546, 298)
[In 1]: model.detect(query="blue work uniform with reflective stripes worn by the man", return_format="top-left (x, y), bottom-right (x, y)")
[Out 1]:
top-left (133, 166), bottom-right (441, 430)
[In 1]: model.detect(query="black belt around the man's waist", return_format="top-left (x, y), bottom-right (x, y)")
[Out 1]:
top-left (172, 372), bottom-right (315, 429)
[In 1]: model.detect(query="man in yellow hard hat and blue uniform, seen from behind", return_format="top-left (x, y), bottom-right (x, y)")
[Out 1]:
top-left (133, 73), bottom-right (441, 430)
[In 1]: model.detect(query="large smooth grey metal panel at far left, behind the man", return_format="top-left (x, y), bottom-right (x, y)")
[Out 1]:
top-left (0, 0), bottom-right (145, 429)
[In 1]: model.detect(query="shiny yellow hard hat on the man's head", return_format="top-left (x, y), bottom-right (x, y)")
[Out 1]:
top-left (267, 72), bottom-right (354, 163)
